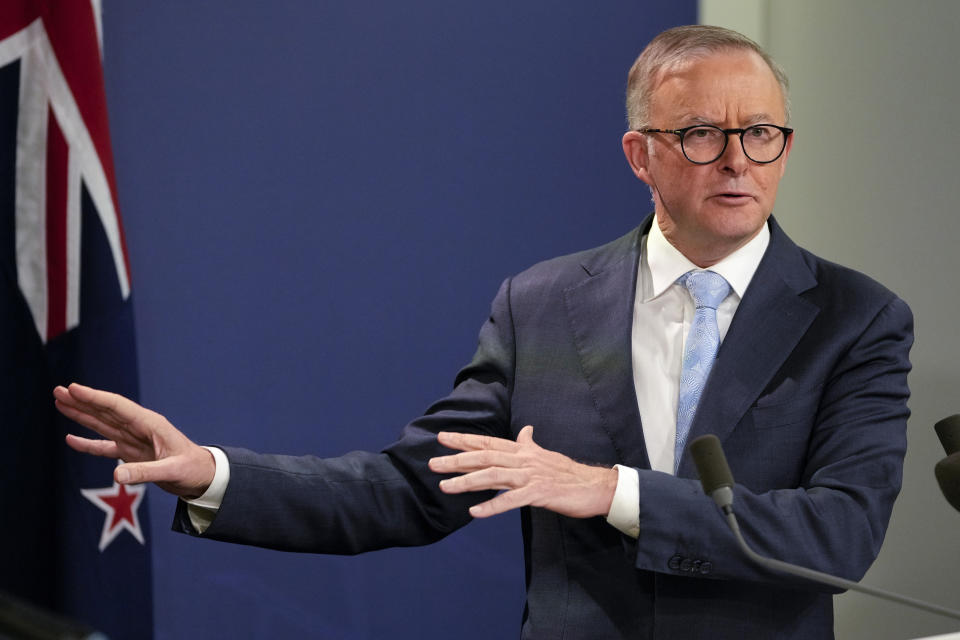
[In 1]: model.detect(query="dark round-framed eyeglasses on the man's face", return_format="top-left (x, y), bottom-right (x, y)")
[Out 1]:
top-left (637, 124), bottom-right (793, 164)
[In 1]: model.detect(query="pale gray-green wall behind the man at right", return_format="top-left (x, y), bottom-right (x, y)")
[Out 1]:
top-left (700, 0), bottom-right (960, 640)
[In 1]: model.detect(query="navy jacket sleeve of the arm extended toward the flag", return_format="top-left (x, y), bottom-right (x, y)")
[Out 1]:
top-left (173, 283), bottom-right (513, 554)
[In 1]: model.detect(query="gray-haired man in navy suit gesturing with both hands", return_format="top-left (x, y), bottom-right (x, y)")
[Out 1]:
top-left (54, 27), bottom-right (912, 639)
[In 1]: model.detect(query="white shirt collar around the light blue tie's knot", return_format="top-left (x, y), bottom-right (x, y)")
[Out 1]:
top-left (643, 217), bottom-right (770, 302)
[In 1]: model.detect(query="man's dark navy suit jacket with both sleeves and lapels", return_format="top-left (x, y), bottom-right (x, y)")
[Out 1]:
top-left (175, 218), bottom-right (912, 640)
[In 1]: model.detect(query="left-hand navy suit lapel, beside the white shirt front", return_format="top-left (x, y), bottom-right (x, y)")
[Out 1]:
top-left (564, 218), bottom-right (650, 469)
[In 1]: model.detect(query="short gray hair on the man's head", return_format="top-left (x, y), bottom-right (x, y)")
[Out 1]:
top-left (627, 25), bottom-right (790, 130)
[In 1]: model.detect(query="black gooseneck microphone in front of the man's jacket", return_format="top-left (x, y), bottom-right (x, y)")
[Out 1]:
top-left (690, 436), bottom-right (960, 620)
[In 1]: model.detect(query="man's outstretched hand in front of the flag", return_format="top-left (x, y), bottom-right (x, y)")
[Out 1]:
top-left (53, 384), bottom-right (216, 499)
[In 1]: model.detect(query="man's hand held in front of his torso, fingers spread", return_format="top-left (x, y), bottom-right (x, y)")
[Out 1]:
top-left (430, 425), bottom-right (619, 518)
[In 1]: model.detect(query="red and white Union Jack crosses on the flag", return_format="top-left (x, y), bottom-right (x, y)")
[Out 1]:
top-left (0, 0), bottom-right (130, 342)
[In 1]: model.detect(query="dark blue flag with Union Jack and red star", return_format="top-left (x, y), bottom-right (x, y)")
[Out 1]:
top-left (0, 0), bottom-right (153, 639)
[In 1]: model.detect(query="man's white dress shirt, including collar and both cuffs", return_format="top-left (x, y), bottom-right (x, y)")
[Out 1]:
top-left (187, 220), bottom-right (770, 538)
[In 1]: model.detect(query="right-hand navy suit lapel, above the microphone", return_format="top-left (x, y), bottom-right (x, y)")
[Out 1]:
top-left (678, 218), bottom-right (819, 477)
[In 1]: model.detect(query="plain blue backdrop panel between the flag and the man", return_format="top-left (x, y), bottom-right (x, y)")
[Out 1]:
top-left (104, 0), bottom-right (696, 639)
